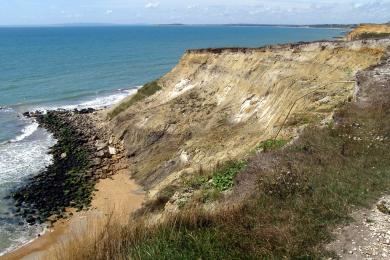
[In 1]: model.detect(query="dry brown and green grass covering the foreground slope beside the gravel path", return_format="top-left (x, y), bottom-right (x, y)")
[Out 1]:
top-left (51, 76), bottom-right (390, 259)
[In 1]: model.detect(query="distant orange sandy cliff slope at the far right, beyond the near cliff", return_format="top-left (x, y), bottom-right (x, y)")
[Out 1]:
top-left (346, 24), bottom-right (390, 41)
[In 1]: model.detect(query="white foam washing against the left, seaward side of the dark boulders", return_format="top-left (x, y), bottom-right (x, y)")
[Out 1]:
top-left (0, 129), bottom-right (56, 256)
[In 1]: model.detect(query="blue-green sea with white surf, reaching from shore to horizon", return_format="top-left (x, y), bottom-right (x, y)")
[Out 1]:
top-left (0, 25), bottom-right (344, 255)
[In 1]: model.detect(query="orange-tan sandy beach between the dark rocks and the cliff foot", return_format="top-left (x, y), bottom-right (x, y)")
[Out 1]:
top-left (3, 170), bottom-right (145, 260)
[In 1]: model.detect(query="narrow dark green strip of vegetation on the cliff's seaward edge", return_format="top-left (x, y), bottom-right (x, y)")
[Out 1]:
top-left (108, 80), bottom-right (161, 119)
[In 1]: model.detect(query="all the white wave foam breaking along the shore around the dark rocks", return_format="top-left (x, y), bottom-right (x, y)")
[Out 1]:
top-left (0, 88), bottom-right (137, 256)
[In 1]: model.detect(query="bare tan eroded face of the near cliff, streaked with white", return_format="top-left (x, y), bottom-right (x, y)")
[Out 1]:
top-left (111, 39), bottom-right (390, 195)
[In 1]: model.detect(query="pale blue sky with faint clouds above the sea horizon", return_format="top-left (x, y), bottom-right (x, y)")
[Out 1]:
top-left (0, 0), bottom-right (390, 25)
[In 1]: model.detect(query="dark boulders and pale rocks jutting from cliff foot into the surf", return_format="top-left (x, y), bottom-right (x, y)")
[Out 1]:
top-left (9, 109), bottom-right (128, 225)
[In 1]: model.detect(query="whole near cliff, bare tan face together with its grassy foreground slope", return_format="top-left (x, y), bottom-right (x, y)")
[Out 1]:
top-left (53, 39), bottom-right (390, 259)
